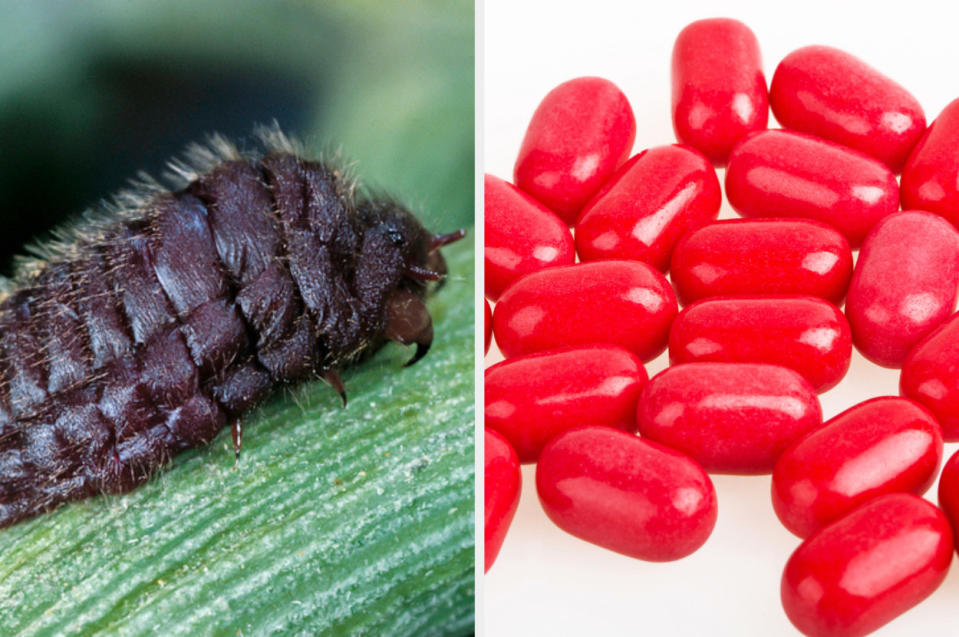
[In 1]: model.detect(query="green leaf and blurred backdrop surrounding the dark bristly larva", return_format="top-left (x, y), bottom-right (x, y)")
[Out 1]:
top-left (0, 0), bottom-right (475, 635)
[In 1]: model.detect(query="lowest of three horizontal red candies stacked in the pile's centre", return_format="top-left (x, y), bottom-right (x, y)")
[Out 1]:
top-left (636, 363), bottom-right (822, 474)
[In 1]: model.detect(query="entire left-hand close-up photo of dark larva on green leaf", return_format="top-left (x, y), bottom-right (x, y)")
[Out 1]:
top-left (0, 2), bottom-right (474, 634)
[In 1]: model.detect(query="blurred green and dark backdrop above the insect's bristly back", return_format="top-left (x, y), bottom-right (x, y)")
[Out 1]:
top-left (0, 0), bottom-right (474, 267)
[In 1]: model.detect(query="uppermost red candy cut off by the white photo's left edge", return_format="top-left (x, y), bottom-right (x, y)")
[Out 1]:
top-left (483, 175), bottom-right (576, 301)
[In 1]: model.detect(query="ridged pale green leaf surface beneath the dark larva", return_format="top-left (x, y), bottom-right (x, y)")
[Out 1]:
top-left (0, 239), bottom-right (474, 635)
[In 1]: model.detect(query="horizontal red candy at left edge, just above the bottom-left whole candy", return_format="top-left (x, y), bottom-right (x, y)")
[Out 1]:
top-left (484, 345), bottom-right (648, 462)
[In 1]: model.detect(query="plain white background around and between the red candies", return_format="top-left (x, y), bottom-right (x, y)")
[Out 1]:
top-left (477, 0), bottom-right (959, 637)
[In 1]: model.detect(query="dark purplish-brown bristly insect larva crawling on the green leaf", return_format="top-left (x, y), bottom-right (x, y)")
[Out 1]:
top-left (0, 126), bottom-right (464, 527)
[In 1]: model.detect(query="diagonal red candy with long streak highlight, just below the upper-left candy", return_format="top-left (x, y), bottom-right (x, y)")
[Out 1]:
top-left (576, 146), bottom-right (722, 271)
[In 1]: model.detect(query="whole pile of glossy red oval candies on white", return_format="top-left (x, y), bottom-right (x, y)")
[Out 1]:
top-left (485, 14), bottom-right (959, 635)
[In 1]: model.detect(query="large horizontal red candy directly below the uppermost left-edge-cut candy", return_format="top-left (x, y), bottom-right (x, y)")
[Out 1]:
top-left (493, 261), bottom-right (677, 361)
